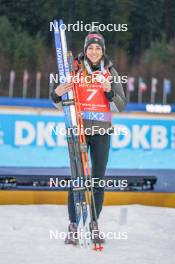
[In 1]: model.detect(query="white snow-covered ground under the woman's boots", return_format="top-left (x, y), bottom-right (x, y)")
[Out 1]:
top-left (0, 205), bottom-right (175, 264)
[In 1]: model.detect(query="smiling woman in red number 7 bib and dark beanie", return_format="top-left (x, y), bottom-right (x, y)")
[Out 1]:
top-left (51, 32), bottom-right (126, 244)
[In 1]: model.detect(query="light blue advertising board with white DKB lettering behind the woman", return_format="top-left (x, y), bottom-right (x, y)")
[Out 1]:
top-left (0, 110), bottom-right (175, 169)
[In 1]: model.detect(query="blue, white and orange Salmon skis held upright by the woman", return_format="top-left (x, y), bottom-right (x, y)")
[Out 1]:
top-left (53, 20), bottom-right (103, 251)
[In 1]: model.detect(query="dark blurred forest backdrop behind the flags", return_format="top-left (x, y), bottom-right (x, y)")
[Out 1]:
top-left (0, 0), bottom-right (175, 103)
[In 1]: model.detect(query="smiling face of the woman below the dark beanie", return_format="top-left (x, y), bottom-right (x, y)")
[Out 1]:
top-left (86, 43), bottom-right (103, 64)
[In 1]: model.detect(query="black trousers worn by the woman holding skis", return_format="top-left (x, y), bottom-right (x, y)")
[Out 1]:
top-left (68, 134), bottom-right (110, 222)
